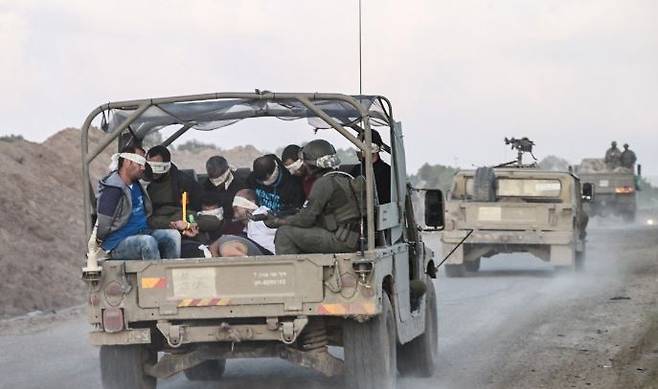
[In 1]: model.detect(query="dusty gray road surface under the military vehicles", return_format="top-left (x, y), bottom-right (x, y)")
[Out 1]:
top-left (0, 226), bottom-right (658, 389)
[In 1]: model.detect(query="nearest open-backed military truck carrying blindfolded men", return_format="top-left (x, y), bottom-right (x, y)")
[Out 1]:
top-left (82, 91), bottom-right (444, 389)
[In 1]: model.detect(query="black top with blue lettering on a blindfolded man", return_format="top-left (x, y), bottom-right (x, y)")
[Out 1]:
top-left (247, 156), bottom-right (306, 215)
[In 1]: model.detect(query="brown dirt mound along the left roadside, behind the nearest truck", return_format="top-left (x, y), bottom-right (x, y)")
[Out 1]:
top-left (0, 128), bottom-right (262, 317)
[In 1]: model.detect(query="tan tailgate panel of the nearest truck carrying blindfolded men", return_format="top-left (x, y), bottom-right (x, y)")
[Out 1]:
top-left (137, 257), bottom-right (323, 308)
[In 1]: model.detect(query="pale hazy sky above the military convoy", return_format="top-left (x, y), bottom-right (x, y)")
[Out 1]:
top-left (0, 0), bottom-right (658, 175)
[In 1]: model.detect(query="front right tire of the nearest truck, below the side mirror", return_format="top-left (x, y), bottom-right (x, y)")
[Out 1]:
top-left (398, 278), bottom-right (439, 378)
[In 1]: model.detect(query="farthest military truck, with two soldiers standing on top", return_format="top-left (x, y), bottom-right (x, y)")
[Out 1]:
top-left (575, 158), bottom-right (642, 222)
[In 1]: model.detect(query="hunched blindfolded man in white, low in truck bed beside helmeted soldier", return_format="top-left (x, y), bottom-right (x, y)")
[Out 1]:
top-left (209, 189), bottom-right (276, 257)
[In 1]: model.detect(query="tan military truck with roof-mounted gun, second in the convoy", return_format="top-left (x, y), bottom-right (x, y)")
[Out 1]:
top-left (441, 138), bottom-right (591, 277)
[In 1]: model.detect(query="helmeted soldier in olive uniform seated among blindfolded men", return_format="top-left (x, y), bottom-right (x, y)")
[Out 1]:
top-left (265, 139), bottom-right (363, 255)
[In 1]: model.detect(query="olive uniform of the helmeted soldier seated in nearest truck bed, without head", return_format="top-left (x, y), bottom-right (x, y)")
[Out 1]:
top-left (274, 171), bottom-right (365, 254)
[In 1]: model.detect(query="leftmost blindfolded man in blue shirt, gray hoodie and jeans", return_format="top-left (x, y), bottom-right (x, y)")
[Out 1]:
top-left (96, 146), bottom-right (181, 259)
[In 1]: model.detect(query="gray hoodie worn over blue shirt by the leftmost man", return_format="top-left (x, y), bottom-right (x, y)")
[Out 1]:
top-left (96, 170), bottom-right (153, 241)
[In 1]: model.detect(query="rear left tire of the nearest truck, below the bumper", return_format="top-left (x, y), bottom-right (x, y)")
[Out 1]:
top-left (100, 344), bottom-right (158, 389)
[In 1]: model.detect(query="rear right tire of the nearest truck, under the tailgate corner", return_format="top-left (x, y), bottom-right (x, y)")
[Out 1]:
top-left (343, 293), bottom-right (397, 389)
